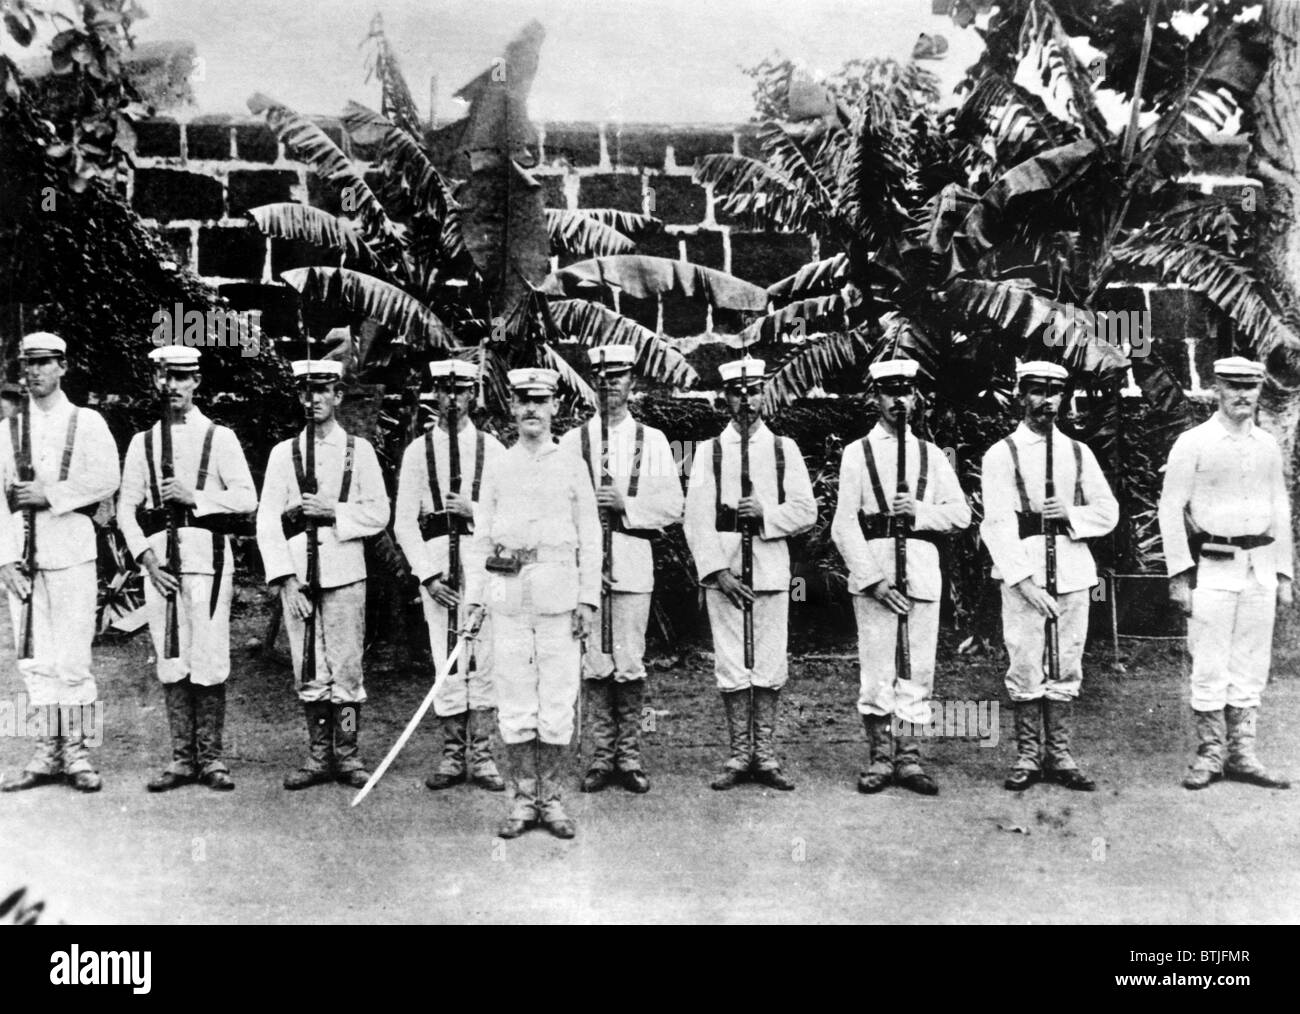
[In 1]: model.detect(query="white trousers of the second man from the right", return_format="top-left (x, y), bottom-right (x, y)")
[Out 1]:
top-left (1002, 584), bottom-right (1091, 701)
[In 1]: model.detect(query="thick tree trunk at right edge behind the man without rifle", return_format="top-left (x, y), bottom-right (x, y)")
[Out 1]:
top-left (1255, 0), bottom-right (1300, 553)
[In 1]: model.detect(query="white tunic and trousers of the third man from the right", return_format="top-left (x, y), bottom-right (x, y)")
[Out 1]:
top-left (831, 423), bottom-right (971, 724)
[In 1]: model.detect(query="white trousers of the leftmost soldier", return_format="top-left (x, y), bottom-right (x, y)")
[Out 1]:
top-left (9, 560), bottom-right (99, 707)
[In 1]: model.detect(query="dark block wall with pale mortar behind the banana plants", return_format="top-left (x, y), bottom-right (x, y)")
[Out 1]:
top-left (130, 116), bottom-right (1262, 390)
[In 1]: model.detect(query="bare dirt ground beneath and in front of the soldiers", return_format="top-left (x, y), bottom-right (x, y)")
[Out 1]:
top-left (0, 585), bottom-right (1300, 923)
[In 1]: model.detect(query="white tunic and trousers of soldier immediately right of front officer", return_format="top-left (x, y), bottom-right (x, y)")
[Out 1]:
top-left (560, 413), bottom-right (684, 683)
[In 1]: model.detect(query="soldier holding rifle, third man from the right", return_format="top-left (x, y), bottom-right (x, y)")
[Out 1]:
top-left (831, 359), bottom-right (971, 796)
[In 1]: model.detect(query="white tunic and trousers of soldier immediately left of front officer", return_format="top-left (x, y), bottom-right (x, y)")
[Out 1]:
top-left (393, 421), bottom-right (506, 716)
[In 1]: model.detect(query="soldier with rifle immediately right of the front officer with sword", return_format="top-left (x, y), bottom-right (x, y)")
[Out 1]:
top-left (560, 345), bottom-right (683, 793)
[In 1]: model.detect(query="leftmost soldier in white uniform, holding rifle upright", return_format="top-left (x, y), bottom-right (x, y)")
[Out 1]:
top-left (0, 332), bottom-right (121, 792)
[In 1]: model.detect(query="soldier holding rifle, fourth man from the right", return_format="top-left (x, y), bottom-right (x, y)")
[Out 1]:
top-left (685, 359), bottom-right (816, 790)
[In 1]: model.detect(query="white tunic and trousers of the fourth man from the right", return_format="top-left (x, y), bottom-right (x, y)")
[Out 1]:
top-left (685, 423), bottom-right (816, 692)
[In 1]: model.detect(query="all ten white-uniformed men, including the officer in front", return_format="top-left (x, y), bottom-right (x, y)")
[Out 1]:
top-left (0, 333), bottom-right (1291, 837)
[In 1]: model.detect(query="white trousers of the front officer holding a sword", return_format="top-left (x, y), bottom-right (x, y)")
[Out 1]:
top-left (491, 612), bottom-right (582, 746)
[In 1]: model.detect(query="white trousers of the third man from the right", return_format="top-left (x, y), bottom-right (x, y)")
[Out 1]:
top-left (853, 595), bottom-right (939, 725)
